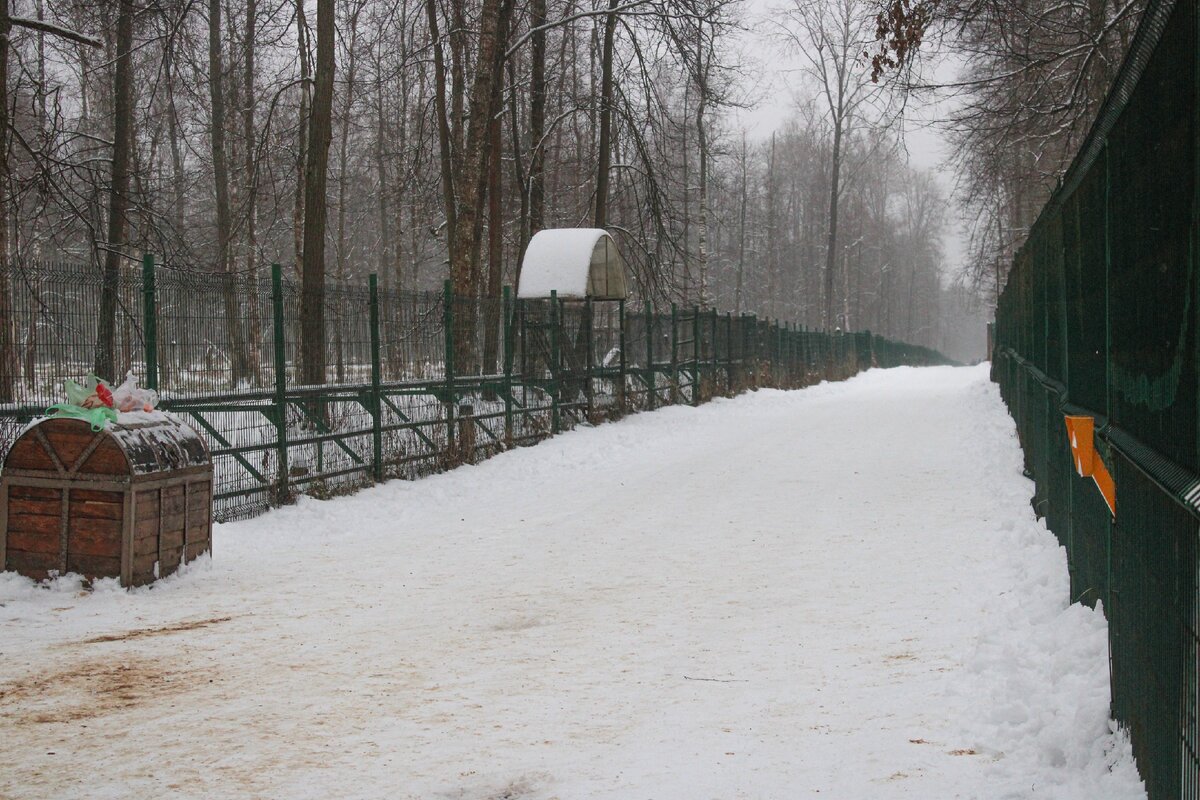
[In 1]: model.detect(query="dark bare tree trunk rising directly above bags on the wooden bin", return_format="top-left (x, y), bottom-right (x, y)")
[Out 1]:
top-left (94, 0), bottom-right (133, 380)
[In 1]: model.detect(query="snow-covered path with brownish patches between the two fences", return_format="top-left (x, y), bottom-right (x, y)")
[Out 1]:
top-left (0, 367), bottom-right (1144, 800)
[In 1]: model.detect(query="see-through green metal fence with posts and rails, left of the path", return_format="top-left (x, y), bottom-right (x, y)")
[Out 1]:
top-left (0, 257), bottom-right (943, 519)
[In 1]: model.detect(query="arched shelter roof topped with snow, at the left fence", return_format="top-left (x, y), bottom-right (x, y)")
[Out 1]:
top-left (517, 228), bottom-right (629, 300)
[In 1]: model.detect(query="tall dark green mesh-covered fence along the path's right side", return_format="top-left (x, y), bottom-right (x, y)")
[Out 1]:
top-left (992, 0), bottom-right (1200, 800)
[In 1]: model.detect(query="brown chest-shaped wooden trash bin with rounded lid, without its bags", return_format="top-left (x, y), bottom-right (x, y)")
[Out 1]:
top-left (0, 413), bottom-right (212, 587)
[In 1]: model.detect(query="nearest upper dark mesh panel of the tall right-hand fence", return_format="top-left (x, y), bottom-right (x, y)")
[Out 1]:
top-left (1106, 2), bottom-right (1200, 470)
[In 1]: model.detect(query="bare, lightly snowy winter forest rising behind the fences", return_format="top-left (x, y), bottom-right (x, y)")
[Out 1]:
top-left (0, 0), bottom-right (1136, 381)
